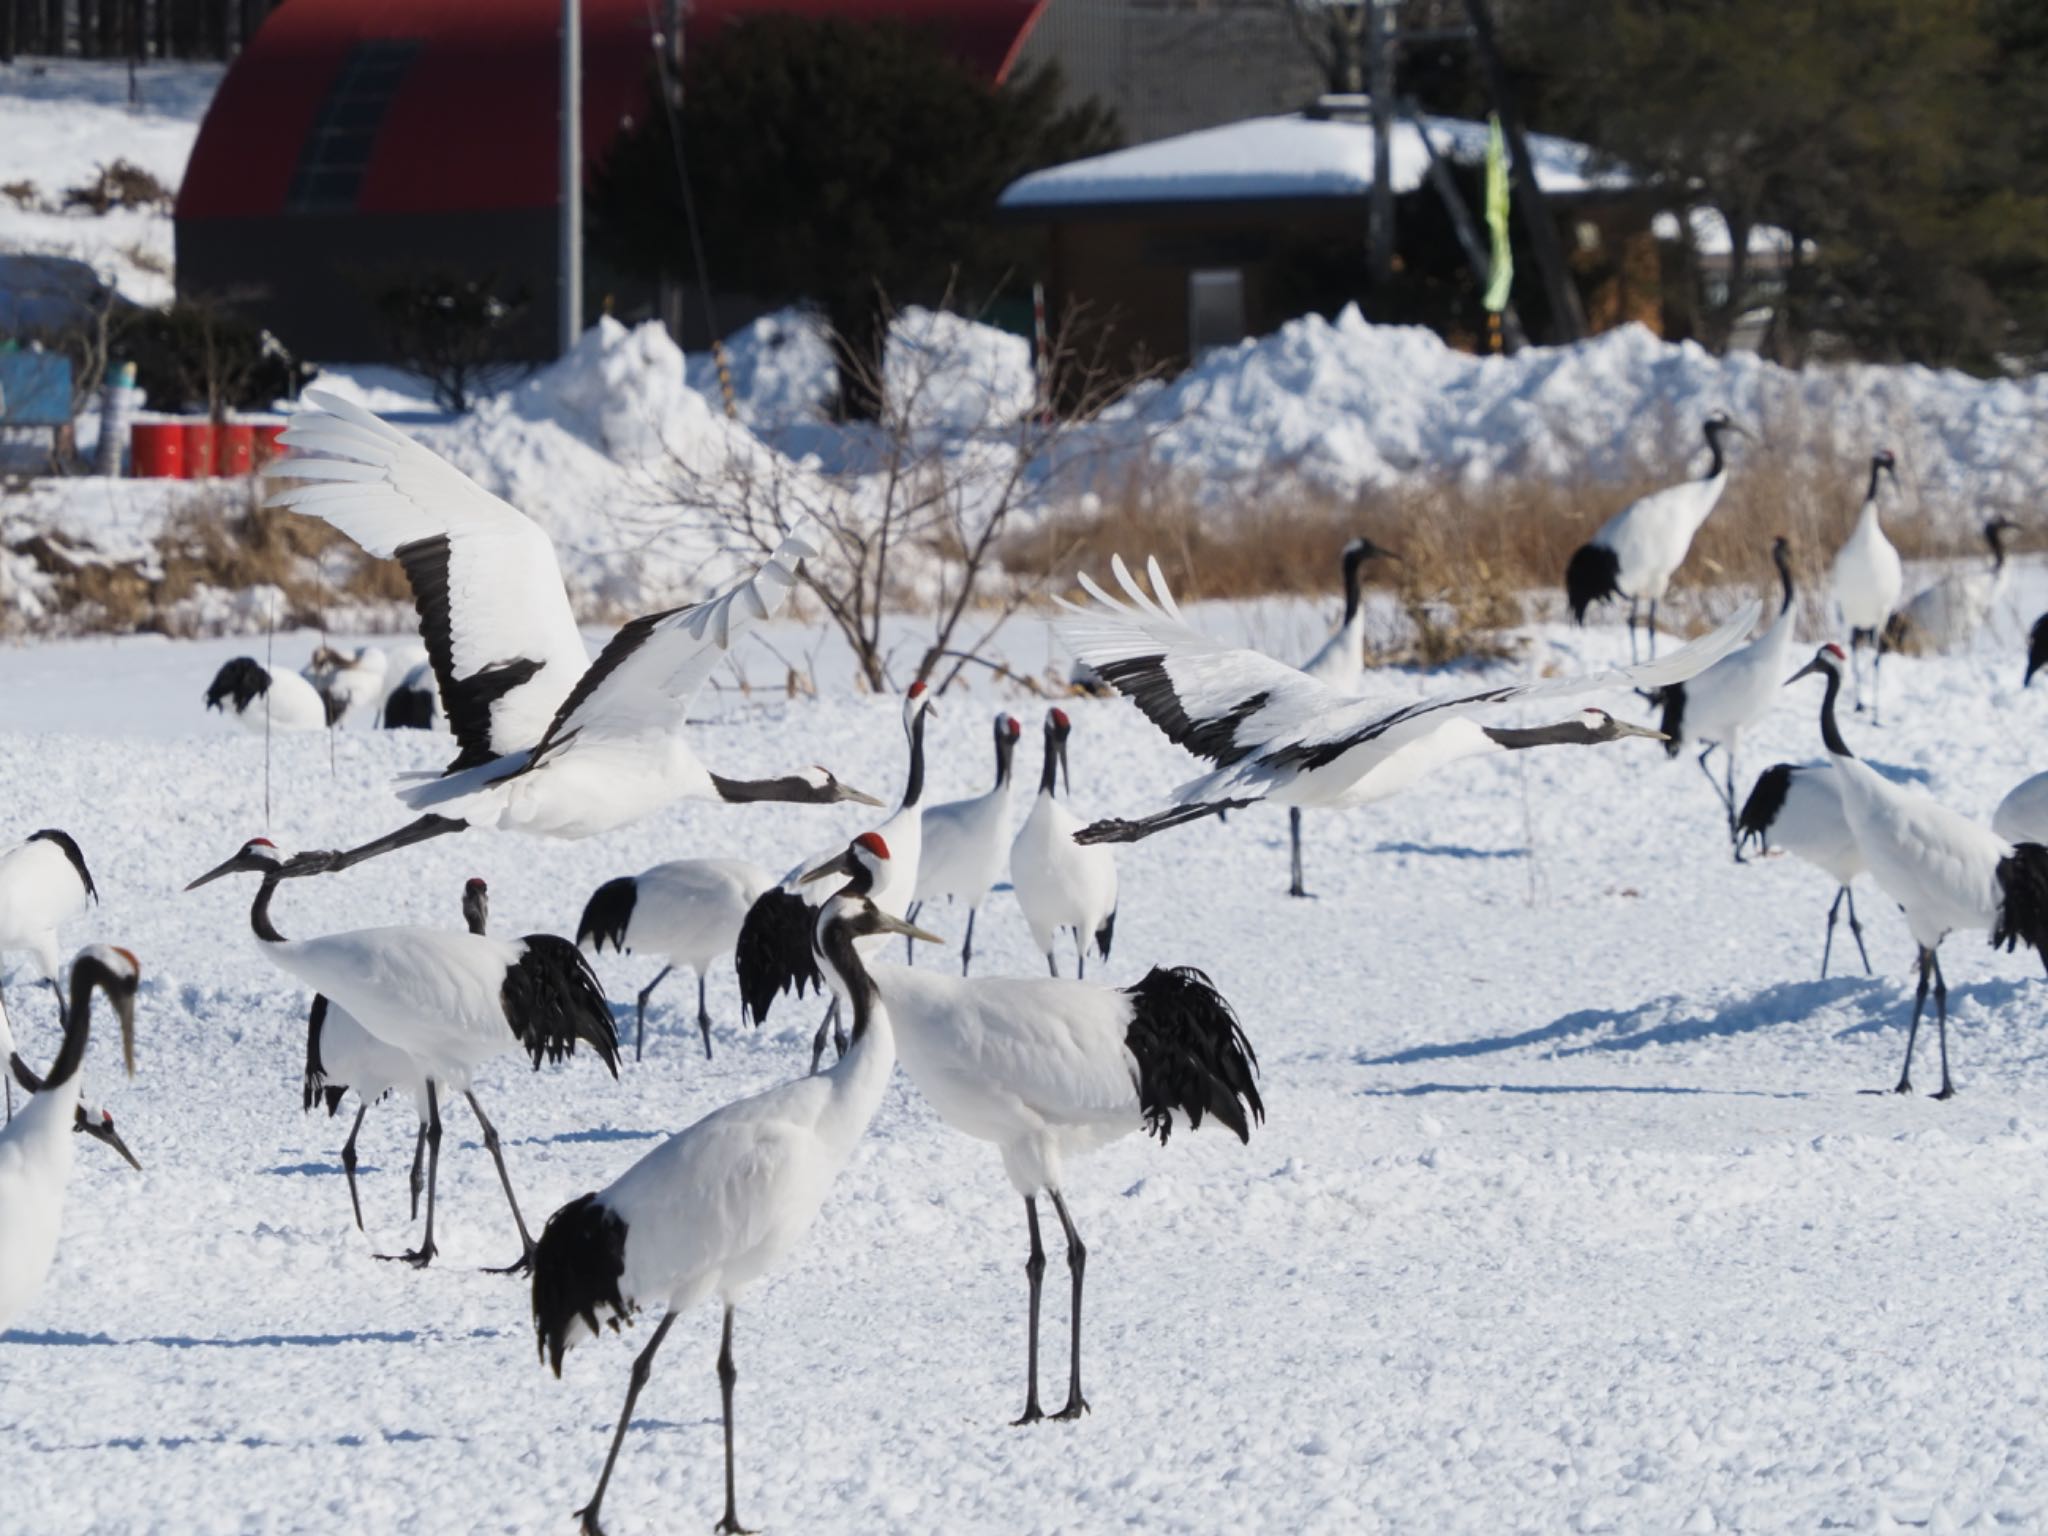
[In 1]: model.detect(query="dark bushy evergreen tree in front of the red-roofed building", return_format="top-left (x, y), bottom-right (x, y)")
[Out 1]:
top-left (590, 14), bottom-right (1116, 416)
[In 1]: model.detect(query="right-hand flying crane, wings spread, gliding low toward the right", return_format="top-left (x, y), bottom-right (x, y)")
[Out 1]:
top-left (1061, 557), bottom-right (1761, 844)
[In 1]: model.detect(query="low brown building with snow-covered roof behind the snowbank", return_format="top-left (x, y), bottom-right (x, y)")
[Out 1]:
top-left (1001, 98), bottom-right (1663, 387)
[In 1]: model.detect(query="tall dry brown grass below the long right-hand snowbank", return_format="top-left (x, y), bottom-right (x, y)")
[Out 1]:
top-left (1006, 411), bottom-right (1982, 664)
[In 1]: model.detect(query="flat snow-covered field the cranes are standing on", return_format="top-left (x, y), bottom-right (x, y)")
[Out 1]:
top-left (0, 582), bottom-right (2048, 1536)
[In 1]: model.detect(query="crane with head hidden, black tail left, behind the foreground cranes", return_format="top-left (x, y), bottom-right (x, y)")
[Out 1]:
top-left (575, 858), bottom-right (774, 1061)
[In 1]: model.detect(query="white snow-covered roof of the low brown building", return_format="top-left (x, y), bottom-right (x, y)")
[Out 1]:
top-left (999, 113), bottom-right (1632, 209)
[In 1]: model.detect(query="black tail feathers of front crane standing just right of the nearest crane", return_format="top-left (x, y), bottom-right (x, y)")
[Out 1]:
top-left (1124, 965), bottom-right (1266, 1147)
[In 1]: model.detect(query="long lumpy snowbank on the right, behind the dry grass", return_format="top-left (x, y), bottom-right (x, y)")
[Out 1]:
top-left (1106, 307), bottom-right (2048, 516)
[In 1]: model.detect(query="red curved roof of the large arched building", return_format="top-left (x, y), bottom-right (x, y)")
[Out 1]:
top-left (178, 0), bottom-right (1044, 219)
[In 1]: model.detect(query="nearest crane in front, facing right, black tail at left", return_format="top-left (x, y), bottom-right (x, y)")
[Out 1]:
top-left (532, 868), bottom-right (938, 1536)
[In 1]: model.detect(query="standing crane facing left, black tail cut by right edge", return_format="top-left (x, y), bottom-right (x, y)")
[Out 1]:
top-left (1790, 645), bottom-right (2048, 1098)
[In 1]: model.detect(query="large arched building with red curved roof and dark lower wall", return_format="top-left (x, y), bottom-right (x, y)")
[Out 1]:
top-left (176, 0), bottom-right (1042, 360)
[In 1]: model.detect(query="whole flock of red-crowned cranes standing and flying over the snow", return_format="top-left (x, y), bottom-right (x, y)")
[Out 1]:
top-left (0, 393), bottom-right (2048, 1532)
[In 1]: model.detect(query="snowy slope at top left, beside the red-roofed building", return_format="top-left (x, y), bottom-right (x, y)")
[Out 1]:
top-left (0, 59), bottom-right (227, 305)
